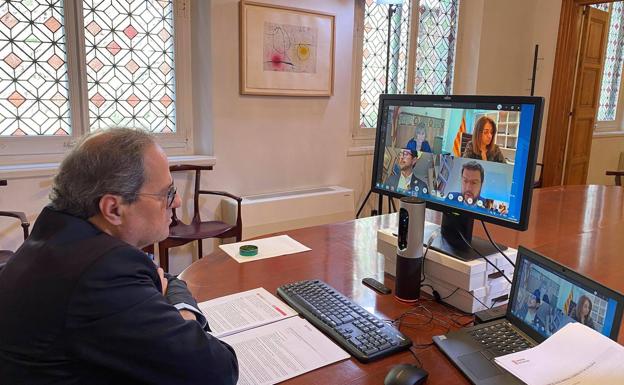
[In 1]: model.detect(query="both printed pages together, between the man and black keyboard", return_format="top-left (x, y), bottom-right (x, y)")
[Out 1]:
top-left (199, 288), bottom-right (350, 385)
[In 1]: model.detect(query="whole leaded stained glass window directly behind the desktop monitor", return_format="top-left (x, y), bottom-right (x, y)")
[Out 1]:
top-left (360, 0), bottom-right (459, 127)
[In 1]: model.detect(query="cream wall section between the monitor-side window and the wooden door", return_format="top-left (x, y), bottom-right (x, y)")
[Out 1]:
top-left (454, 0), bottom-right (561, 164)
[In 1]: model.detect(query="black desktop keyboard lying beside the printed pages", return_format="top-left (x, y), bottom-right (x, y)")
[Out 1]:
top-left (277, 280), bottom-right (412, 362)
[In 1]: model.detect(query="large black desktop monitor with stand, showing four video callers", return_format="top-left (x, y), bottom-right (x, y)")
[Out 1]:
top-left (372, 95), bottom-right (544, 260)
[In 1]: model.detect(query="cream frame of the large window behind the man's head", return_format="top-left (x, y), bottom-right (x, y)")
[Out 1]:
top-left (0, 0), bottom-right (193, 165)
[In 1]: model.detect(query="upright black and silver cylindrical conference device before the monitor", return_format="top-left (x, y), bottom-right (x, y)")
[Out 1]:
top-left (394, 197), bottom-right (425, 302)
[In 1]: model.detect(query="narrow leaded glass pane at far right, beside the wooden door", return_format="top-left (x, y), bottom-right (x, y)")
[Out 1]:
top-left (598, 2), bottom-right (624, 121)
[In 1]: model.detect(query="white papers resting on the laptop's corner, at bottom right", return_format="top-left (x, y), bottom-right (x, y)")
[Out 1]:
top-left (495, 322), bottom-right (624, 385)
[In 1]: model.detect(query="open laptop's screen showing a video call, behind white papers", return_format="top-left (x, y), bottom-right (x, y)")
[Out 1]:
top-left (509, 248), bottom-right (622, 339)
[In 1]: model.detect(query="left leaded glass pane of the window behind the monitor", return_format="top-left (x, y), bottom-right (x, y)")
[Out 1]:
top-left (360, 0), bottom-right (411, 127)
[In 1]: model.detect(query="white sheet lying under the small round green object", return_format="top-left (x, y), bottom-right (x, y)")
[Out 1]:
top-left (219, 235), bottom-right (311, 263)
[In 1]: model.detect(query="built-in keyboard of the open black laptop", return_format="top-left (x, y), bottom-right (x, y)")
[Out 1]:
top-left (470, 322), bottom-right (532, 357)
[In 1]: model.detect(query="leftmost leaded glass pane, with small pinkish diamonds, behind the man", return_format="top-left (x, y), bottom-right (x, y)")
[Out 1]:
top-left (0, 0), bottom-right (71, 136)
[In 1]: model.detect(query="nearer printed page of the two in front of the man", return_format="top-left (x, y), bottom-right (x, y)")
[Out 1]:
top-left (222, 317), bottom-right (350, 385)
